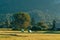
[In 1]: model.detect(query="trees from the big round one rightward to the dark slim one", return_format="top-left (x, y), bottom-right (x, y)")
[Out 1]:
top-left (13, 12), bottom-right (56, 30)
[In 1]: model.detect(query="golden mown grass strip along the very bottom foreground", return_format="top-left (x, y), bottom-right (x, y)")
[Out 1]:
top-left (0, 34), bottom-right (60, 40)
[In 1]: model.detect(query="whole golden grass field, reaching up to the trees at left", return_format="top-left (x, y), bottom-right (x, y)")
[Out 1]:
top-left (0, 31), bottom-right (60, 40)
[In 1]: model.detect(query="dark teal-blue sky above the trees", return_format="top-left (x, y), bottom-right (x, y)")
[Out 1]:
top-left (0, 0), bottom-right (60, 20)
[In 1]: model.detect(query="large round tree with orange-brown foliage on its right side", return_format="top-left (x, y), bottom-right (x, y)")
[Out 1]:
top-left (13, 12), bottom-right (31, 30)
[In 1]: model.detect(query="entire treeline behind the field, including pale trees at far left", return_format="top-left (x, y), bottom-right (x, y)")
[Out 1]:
top-left (0, 12), bottom-right (56, 31)
